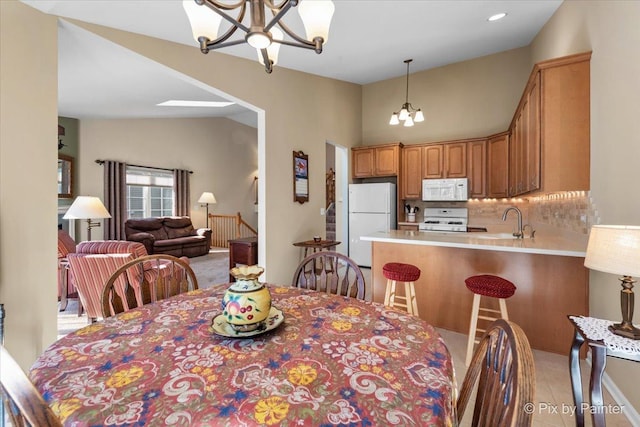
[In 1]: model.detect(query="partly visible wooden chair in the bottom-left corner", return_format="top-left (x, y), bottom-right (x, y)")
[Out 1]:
top-left (0, 345), bottom-right (62, 427)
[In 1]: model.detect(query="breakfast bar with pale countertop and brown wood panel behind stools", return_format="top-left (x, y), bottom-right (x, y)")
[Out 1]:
top-left (361, 230), bottom-right (589, 354)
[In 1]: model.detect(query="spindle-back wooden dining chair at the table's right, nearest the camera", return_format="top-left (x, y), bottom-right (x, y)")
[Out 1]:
top-left (456, 319), bottom-right (536, 427)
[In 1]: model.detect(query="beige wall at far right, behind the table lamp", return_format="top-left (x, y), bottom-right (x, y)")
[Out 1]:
top-left (531, 1), bottom-right (640, 411)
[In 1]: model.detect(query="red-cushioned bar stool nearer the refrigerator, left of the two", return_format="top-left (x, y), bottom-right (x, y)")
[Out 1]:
top-left (382, 262), bottom-right (420, 316)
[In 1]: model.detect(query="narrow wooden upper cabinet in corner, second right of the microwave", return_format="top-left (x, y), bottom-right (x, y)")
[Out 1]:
top-left (487, 133), bottom-right (509, 198)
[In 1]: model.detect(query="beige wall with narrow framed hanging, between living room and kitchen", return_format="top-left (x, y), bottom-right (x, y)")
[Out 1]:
top-left (67, 23), bottom-right (362, 283)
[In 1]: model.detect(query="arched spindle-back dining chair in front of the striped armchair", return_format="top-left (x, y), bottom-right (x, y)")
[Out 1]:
top-left (102, 254), bottom-right (198, 318)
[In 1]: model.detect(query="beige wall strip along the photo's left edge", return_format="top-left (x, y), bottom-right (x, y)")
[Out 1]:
top-left (0, 1), bottom-right (58, 369)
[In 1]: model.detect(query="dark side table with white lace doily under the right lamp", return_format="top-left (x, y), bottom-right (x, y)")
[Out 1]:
top-left (567, 316), bottom-right (640, 427)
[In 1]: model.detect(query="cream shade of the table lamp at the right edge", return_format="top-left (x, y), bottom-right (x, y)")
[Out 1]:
top-left (584, 225), bottom-right (640, 277)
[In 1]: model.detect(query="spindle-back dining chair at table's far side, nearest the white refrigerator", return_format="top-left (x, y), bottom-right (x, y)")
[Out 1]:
top-left (291, 251), bottom-right (365, 300)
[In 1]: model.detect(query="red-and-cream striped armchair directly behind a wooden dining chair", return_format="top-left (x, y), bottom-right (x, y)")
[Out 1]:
top-left (67, 240), bottom-right (147, 320)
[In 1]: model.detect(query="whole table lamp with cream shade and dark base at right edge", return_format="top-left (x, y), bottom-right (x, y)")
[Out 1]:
top-left (584, 225), bottom-right (640, 340)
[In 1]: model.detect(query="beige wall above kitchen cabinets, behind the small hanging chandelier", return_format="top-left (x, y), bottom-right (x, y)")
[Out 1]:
top-left (362, 47), bottom-right (532, 145)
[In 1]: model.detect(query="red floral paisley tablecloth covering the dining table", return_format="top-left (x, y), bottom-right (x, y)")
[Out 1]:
top-left (30, 285), bottom-right (455, 426)
